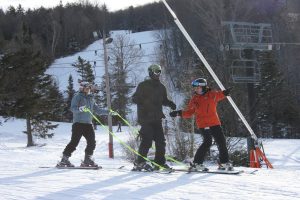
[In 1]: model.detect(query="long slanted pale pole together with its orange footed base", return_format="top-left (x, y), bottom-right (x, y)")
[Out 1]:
top-left (161, 0), bottom-right (273, 169)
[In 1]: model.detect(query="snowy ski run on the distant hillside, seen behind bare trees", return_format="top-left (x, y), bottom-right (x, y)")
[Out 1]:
top-left (47, 30), bottom-right (159, 91)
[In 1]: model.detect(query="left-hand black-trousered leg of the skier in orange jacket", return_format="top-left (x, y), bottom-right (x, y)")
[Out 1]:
top-left (193, 129), bottom-right (212, 164)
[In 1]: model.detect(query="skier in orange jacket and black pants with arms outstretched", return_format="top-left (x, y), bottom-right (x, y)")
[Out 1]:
top-left (170, 78), bottom-right (233, 171)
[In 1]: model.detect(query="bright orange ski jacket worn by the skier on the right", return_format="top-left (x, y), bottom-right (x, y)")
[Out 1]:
top-left (182, 90), bottom-right (226, 128)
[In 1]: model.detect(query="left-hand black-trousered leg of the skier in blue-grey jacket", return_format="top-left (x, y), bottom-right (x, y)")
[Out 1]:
top-left (63, 123), bottom-right (83, 157)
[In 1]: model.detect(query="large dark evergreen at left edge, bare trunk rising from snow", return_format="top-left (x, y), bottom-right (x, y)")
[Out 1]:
top-left (0, 24), bottom-right (58, 146)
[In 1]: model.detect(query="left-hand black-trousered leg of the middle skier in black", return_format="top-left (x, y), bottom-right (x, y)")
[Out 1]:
top-left (137, 123), bottom-right (153, 163)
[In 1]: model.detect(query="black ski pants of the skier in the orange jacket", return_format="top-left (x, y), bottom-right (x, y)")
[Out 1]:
top-left (194, 126), bottom-right (229, 164)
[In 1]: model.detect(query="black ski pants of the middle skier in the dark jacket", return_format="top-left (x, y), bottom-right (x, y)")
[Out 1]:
top-left (137, 120), bottom-right (166, 165)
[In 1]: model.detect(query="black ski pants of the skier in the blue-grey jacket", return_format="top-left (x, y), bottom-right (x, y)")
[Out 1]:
top-left (63, 123), bottom-right (96, 157)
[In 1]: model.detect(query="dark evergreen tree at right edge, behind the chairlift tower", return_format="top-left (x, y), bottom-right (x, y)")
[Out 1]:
top-left (257, 52), bottom-right (300, 138)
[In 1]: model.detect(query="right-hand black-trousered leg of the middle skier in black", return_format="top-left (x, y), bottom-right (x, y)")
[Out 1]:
top-left (152, 120), bottom-right (166, 165)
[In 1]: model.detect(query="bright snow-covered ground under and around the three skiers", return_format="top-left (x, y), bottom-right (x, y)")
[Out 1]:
top-left (0, 116), bottom-right (300, 200)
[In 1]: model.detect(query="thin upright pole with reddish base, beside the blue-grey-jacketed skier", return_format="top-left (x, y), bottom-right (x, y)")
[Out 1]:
top-left (103, 31), bottom-right (114, 158)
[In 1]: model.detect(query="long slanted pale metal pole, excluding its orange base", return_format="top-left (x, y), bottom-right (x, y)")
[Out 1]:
top-left (162, 0), bottom-right (257, 141)
